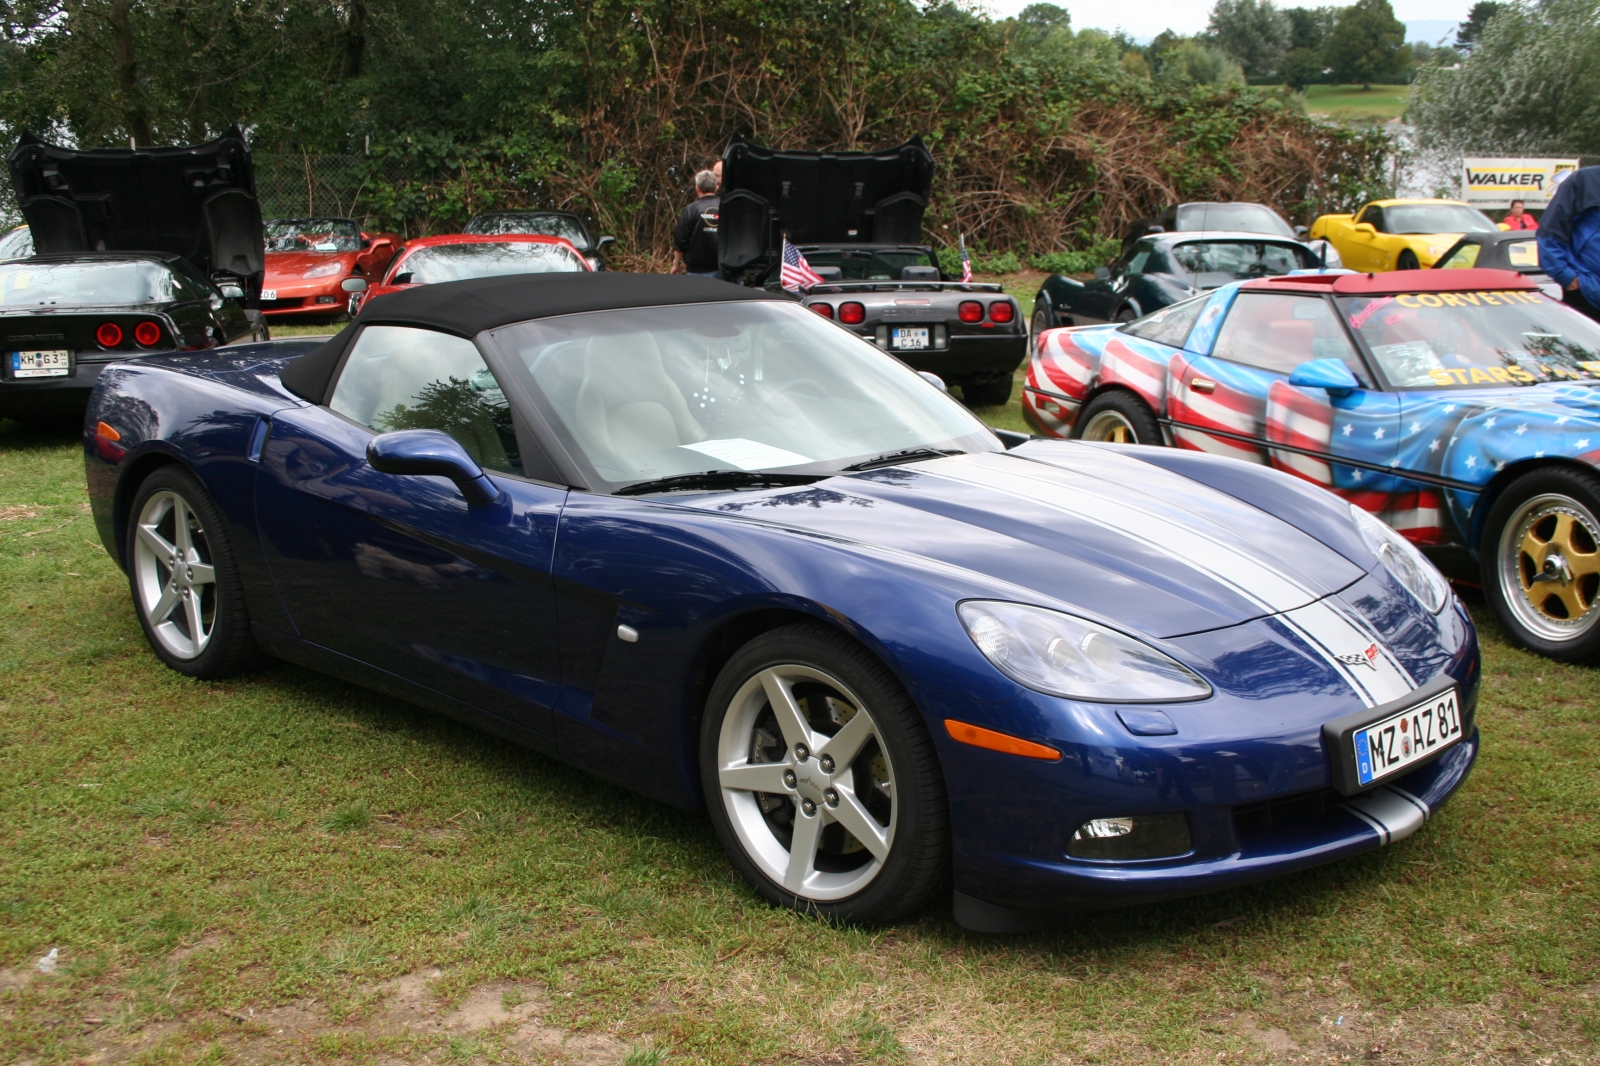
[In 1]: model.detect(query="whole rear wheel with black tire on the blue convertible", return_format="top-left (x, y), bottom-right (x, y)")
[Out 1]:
top-left (125, 464), bottom-right (264, 679)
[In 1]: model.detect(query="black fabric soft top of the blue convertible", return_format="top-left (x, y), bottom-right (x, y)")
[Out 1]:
top-left (280, 272), bottom-right (784, 403)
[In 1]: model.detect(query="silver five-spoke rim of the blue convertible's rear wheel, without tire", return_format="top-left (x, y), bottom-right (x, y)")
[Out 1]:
top-left (133, 490), bottom-right (216, 659)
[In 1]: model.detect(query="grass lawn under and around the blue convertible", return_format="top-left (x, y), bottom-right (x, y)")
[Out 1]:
top-left (0, 361), bottom-right (1600, 1066)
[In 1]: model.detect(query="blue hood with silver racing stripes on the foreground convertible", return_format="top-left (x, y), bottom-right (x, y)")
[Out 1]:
top-left (698, 443), bottom-right (1376, 639)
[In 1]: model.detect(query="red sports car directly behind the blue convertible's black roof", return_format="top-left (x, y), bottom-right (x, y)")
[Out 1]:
top-left (350, 234), bottom-right (594, 315)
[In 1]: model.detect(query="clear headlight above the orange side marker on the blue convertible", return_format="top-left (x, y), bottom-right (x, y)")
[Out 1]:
top-left (955, 600), bottom-right (1211, 703)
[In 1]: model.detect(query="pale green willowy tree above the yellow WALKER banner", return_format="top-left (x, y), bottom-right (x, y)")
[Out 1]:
top-left (1408, 0), bottom-right (1600, 158)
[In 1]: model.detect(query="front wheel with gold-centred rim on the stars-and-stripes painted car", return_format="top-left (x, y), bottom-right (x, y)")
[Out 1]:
top-left (1478, 466), bottom-right (1600, 663)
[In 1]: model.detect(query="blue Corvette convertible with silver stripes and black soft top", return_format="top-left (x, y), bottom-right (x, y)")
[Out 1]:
top-left (85, 274), bottom-right (1478, 930)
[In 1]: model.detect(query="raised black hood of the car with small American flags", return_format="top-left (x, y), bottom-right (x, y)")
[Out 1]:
top-left (717, 134), bottom-right (933, 272)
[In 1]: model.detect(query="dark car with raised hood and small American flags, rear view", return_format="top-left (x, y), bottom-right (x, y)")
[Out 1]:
top-left (717, 136), bottom-right (1027, 407)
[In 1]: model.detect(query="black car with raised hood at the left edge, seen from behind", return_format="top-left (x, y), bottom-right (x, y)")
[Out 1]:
top-left (0, 128), bottom-right (266, 418)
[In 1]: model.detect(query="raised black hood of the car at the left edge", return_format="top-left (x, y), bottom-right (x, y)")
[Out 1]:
top-left (8, 126), bottom-right (264, 284)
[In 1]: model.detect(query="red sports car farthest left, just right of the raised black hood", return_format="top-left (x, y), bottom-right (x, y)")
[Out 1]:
top-left (261, 218), bottom-right (400, 320)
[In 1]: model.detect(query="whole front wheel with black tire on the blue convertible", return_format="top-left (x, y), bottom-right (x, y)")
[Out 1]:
top-left (701, 623), bottom-right (950, 924)
